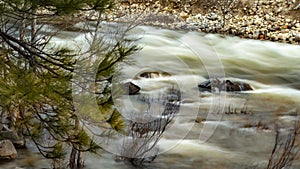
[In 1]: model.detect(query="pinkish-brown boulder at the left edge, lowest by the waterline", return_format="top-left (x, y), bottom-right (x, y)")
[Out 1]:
top-left (0, 140), bottom-right (18, 160)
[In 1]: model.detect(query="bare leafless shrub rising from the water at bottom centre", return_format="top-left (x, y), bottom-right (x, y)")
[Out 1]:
top-left (118, 87), bottom-right (180, 166)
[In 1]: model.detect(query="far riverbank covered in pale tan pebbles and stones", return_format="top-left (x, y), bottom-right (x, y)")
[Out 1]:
top-left (99, 0), bottom-right (300, 44)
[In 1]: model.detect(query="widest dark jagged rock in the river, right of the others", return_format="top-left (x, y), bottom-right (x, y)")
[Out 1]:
top-left (198, 79), bottom-right (253, 92)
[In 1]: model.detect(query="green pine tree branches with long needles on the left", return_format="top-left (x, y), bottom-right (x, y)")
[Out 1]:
top-left (0, 0), bottom-right (137, 168)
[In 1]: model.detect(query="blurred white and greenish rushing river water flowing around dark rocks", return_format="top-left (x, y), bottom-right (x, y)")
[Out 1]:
top-left (0, 24), bottom-right (300, 169)
